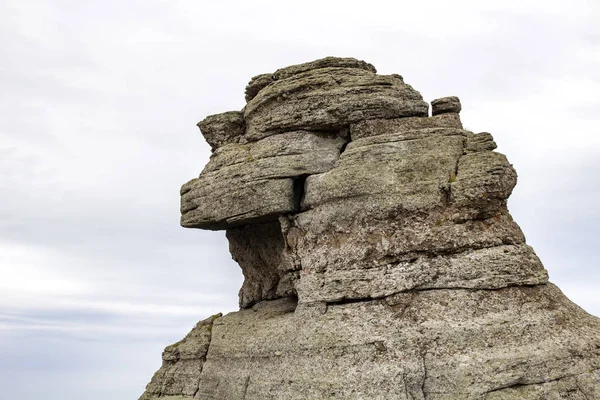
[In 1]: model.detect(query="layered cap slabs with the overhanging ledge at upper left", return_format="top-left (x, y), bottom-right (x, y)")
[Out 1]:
top-left (181, 57), bottom-right (440, 229)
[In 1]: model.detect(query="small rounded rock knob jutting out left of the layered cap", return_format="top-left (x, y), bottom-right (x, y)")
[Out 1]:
top-left (198, 111), bottom-right (246, 151)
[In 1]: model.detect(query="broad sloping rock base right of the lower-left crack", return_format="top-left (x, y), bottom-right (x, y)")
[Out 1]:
top-left (196, 285), bottom-right (600, 400)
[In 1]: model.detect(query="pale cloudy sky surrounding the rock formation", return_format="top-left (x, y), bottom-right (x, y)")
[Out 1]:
top-left (0, 0), bottom-right (600, 400)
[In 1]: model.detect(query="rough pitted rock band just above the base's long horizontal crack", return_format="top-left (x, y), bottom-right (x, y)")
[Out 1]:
top-left (294, 206), bottom-right (536, 303)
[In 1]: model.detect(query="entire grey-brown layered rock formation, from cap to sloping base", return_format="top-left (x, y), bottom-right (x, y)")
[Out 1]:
top-left (142, 57), bottom-right (600, 400)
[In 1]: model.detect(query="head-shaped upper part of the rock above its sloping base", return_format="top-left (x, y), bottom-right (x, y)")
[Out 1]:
top-left (181, 57), bottom-right (536, 307)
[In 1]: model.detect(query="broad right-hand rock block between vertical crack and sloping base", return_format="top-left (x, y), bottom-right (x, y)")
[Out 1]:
top-left (293, 114), bottom-right (524, 303)
